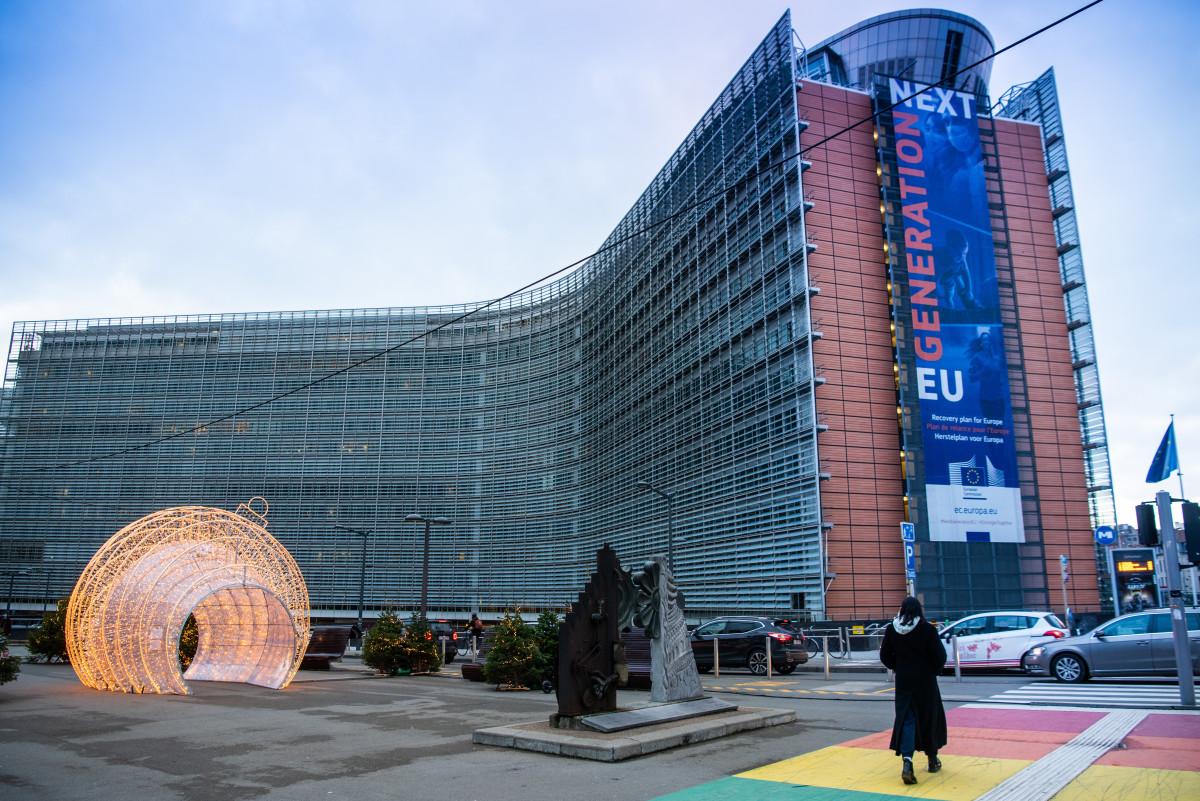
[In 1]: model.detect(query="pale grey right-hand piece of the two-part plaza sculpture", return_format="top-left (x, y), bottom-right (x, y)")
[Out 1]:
top-left (631, 556), bottom-right (704, 703)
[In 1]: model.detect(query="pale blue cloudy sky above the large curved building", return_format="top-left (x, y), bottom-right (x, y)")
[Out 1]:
top-left (0, 0), bottom-right (1200, 532)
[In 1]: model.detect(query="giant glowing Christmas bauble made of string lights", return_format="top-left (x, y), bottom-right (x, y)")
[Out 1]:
top-left (66, 498), bottom-right (311, 695)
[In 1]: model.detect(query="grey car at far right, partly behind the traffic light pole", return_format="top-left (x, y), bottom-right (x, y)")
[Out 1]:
top-left (1021, 609), bottom-right (1200, 681)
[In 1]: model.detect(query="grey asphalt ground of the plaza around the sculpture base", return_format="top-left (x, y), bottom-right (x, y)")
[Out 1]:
top-left (0, 664), bottom-right (1024, 801)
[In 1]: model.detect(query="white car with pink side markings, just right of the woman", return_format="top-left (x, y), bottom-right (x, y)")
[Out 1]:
top-left (941, 612), bottom-right (1070, 669)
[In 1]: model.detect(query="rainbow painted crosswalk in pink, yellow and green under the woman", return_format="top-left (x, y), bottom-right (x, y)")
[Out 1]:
top-left (660, 705), bottom-right (1200, 801)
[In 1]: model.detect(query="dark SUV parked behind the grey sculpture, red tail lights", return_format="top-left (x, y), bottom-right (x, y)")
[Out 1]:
top-left (691, 618), bottom-right (809, 676)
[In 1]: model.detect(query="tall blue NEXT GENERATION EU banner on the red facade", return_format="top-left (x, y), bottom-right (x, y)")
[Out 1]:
top-left (890, 79), bottom-right (1025, 542)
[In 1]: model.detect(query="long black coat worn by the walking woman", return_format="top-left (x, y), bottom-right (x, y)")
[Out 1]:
top-left (880, 620), bottom-right (946, 755)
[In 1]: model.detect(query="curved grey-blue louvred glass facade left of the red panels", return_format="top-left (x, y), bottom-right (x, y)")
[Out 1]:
top-left (0, 14), bottom-right (823, 616)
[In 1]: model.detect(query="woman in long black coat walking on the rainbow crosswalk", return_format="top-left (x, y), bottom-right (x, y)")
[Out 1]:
top-left (880, 597), bottom-right (946, 784)
